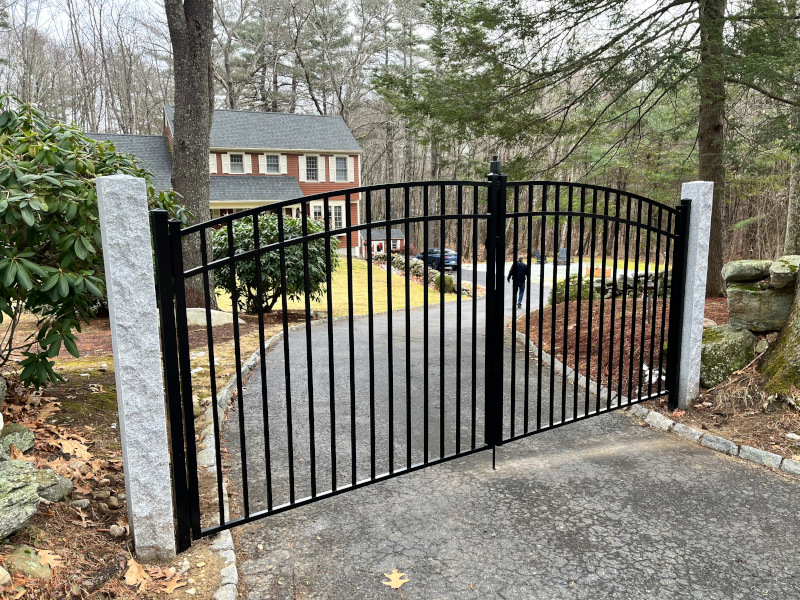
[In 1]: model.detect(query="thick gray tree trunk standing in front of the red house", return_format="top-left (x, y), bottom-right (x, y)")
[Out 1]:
top-left (164, 0), bottom-right (216, 308)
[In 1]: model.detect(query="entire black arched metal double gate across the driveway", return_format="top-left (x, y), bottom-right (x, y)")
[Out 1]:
top-left (152, 159), bottom-right (690, 549)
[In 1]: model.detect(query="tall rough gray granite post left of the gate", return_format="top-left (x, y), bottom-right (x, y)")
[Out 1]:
top-left (96, 175), bottom-right (175, 562)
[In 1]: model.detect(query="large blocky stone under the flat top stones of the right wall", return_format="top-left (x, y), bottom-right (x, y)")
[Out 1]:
top-left (728, 283), bottom-right (794, 332)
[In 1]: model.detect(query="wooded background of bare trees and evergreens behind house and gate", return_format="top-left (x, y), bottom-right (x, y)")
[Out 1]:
top-left (0, 0), bottom-right (800, 286)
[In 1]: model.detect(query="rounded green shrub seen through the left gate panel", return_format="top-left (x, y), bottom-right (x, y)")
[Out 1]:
top-left (212, 213), bottom-right (339, 313)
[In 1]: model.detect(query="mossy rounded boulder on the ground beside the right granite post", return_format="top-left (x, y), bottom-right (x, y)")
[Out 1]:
top-left (700, 325), bottom-right (758, 388)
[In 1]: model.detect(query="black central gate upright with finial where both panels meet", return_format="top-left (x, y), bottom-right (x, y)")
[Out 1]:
top-left (485, 156), bottom-right (508, 447)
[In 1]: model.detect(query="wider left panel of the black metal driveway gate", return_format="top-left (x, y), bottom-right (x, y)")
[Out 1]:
top-left (174, 182), bottom-right (489, 537)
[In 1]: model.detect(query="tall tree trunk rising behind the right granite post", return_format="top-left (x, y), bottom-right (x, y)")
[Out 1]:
top-left (697, 0), bottom-right (725, 297)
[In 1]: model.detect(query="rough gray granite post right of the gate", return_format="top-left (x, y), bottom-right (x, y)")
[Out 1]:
top-left (678, 181), bottom-right (714, 409)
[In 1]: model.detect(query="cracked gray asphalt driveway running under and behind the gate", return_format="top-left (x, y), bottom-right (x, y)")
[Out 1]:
top-left (220, 274), bottom-right (800, 600)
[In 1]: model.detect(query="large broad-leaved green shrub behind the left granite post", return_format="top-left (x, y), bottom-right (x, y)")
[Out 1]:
top-left (0, 94), bottom-right (186, 387)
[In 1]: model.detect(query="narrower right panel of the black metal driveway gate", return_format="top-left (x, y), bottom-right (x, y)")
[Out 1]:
top-left (502, 181), bottom-right (684, 441)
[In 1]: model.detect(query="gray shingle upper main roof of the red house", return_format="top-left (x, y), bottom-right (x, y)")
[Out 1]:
top-left (164, 106), bottom-right (361, 152)
